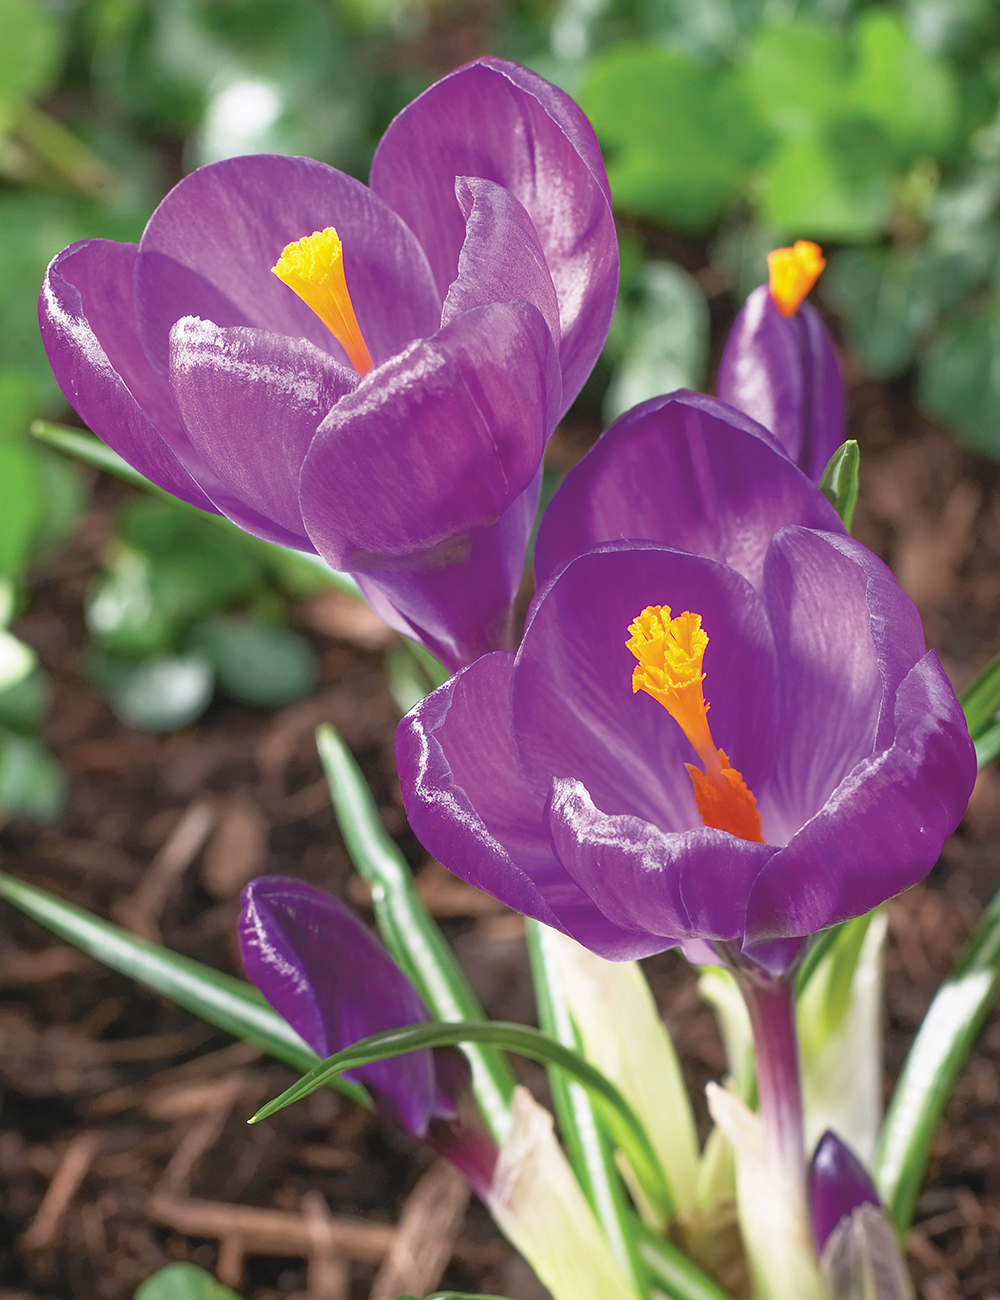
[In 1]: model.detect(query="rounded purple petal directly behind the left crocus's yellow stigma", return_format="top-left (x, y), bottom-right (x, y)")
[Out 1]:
top-left (135, 153), bottom-right (439, 376)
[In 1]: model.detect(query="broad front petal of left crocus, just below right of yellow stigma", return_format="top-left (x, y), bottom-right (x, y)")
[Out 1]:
top-left (300, 303), bottom-right (559, 573)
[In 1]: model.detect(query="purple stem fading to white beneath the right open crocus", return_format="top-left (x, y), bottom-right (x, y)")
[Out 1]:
top-left (735, 967), bottom-right (806, 1190)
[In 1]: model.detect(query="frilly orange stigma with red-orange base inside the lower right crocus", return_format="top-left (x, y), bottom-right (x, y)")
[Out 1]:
top-left (625, 605), bottom-right (763, 844)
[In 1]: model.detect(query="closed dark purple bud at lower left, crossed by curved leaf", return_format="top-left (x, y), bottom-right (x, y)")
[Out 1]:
top-left (239, 876), bottom-right (436, 1138)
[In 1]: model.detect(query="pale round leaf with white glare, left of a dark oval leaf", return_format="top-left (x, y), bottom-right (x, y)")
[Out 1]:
top-left (90, 654), bottom-right (215, 735)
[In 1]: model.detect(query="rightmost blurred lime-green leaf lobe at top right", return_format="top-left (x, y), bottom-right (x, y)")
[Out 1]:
top-left (852, 8), bottom-right (958, 159)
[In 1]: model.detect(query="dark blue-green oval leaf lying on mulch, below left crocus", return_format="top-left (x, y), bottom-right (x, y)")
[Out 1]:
top-left (190, 615), bottom-right (320, 709)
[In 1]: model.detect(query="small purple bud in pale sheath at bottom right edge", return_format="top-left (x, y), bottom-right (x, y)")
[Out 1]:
top-left (809, 1131), bottom-right (913, 1300)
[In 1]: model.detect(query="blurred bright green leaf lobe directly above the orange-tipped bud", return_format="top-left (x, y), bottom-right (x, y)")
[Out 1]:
top-left (761, 121), bottom-right (893, 243)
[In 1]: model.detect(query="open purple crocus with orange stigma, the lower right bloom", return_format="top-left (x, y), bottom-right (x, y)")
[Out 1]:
top-left (397, 394), bottom-right (975, 963)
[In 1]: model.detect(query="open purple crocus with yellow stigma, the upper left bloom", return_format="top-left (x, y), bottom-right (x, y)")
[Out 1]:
top-left (40, 59), bottom-right (618, 667)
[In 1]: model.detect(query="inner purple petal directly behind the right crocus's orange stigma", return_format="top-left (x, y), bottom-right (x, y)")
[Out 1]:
top-left (511, 543), bottom-right (776, 831)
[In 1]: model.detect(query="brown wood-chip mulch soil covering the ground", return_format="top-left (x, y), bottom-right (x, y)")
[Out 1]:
top-left (0, 287), bottom-right (1000, 1300)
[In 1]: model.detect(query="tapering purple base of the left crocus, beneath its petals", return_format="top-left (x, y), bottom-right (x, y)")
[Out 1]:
top-left (356, 468), bottom-right (541, 671)
